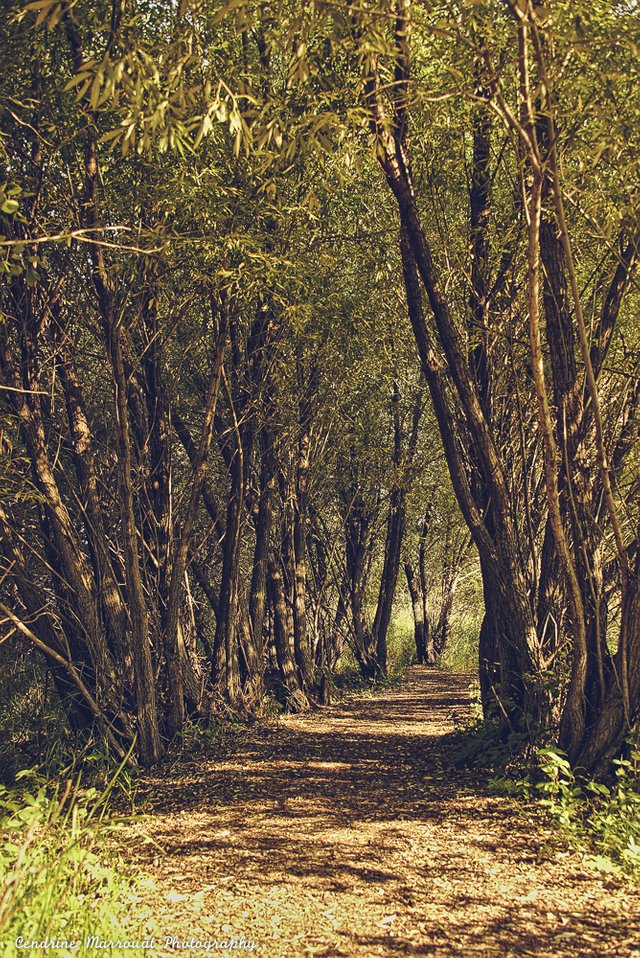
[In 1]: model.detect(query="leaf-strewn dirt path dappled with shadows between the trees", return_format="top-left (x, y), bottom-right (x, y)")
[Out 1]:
top-left (129, 667), bottom-right (640, 958)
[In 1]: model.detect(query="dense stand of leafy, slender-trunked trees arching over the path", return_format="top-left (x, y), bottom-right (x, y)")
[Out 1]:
top-left (0, 0), bottom-right (640, 776)
